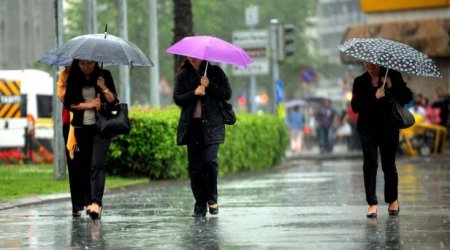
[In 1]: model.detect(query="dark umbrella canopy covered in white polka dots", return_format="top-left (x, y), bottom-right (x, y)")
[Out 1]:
top-left (337, 38), bottom-right (442, 78)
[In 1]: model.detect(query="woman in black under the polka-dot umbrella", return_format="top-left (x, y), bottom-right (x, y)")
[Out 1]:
top-left (351, 62), bottom-right (412, 218)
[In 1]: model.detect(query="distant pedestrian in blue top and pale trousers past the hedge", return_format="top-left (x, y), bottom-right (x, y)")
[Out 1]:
top-left (287, 105), bottom-right (305, 153)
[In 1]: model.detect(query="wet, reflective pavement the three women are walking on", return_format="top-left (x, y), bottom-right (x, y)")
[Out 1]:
top-left (0, 146), bottom-right (450, 249)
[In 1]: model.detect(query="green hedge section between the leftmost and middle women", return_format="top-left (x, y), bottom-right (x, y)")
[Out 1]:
top-left (110, 107), bottom-right (187, 179)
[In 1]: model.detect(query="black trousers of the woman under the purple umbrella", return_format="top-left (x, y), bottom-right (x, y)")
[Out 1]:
top-left (187, 119), bottom-right (220, 210)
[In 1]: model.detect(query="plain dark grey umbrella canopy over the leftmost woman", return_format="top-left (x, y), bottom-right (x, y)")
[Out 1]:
top-left (39, 33), bottom-right (153, 66)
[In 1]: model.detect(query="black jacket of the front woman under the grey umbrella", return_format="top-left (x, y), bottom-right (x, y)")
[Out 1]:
top-left (64, 70), bottom-right (117, 127)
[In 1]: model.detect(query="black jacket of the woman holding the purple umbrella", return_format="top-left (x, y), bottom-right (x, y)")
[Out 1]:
top-left (173, 61), bottom-right (231, 145)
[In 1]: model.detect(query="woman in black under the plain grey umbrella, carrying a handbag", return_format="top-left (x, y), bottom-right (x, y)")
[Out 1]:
top-left (64, 59), bottom-right (117, 220)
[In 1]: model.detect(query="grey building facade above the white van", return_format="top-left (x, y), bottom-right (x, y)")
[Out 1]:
top-left (0, 0), bottom-right (56, 70)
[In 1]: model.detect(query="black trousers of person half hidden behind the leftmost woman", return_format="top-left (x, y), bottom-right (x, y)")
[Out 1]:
top-left (63, 124), bottom-right (90, 211)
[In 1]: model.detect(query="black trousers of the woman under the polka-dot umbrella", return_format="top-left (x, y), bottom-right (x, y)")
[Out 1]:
top-left (360, 130), bottom-right (399, 205)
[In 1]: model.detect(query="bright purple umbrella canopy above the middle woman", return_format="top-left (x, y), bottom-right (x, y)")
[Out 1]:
top-left (166, 36), bottom-right (252, 67)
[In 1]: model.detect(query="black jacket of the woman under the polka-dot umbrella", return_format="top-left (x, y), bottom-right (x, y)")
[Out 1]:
top-left (351, 69), bottom-right (412, 133)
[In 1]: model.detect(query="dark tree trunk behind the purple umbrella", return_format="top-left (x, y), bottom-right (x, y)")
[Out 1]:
top-left (173, 0), bottom-right (194, 72)
